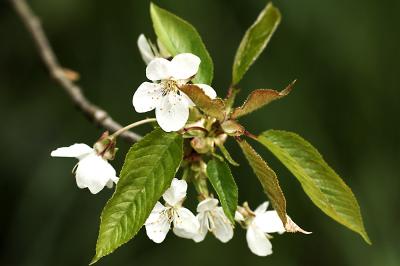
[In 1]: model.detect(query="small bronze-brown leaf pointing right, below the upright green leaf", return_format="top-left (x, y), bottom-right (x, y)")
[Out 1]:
top-left (231, 80), bottom-right (296, 119)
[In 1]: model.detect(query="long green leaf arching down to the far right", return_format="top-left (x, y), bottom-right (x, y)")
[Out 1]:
top-left (258, 130), bottom-right (371, 244)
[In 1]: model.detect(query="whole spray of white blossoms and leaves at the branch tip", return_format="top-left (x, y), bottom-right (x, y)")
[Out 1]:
top-left (45, 3), bottom-right (371, 264)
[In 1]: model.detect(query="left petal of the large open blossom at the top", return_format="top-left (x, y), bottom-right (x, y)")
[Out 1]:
top-left (132, 82), bottom-right (162, 113)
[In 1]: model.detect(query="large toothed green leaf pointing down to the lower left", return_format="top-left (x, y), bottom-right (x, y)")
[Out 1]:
top-left (91, 129), bottom-right (183, 264)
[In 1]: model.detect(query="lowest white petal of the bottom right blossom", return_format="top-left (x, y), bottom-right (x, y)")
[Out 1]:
top-left (246, 226), bottom-right (272, 256)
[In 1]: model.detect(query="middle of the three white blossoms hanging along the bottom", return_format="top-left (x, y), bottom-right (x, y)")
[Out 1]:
top-left (193, 198), bottom-right (233, 243)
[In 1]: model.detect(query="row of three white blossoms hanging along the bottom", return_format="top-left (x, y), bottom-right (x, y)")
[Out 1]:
top-left (145, 178), bottom-right (285, 256)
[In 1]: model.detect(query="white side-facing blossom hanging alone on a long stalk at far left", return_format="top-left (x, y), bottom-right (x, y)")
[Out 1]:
top-left (51, 144), bottom-right (118, 194)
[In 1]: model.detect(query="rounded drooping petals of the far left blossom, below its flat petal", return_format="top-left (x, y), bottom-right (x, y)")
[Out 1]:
top-left (75, 154), bottom-right (116, 194)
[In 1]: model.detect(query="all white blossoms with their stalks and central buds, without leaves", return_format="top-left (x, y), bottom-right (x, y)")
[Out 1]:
top-left (51, 35), bottom-right (306, 256)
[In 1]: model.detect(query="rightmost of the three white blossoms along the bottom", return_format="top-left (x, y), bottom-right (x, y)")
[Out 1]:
top-left (235, 202), bottom-right (285, 256)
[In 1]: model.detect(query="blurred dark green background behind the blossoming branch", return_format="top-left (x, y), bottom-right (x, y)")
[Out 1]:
top-left (0, 0), bottom-right (400, 266)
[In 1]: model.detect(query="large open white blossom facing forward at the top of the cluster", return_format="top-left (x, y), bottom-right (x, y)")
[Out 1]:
top-left (132, 53), bottom-right (217, 132)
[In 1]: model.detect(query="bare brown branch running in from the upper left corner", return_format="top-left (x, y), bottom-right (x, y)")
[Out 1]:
top-left (10, 0), bottom-right (141, 142)
